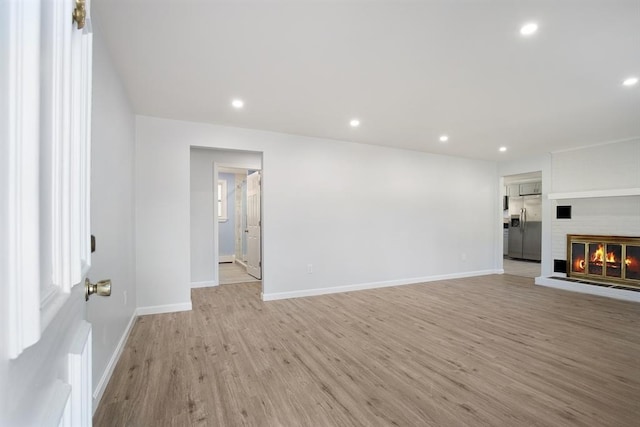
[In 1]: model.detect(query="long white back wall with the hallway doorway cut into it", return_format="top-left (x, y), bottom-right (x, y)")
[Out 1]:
top-left (136, 116), bottom-right (499, 307)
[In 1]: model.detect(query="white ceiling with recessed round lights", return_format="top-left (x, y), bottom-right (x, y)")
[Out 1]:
top-left (92, 0), bottom-right (640, 160)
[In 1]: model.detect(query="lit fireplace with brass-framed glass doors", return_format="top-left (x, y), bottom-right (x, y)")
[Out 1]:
top-left (567, 234), bottom-right (640, 289)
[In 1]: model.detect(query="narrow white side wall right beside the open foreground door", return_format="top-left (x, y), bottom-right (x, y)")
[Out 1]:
top-left (87, 30), bottom-right (136, 407)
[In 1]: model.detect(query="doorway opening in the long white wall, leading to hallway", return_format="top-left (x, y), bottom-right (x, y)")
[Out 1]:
top-left (190, 147), bottom-right (264, 288)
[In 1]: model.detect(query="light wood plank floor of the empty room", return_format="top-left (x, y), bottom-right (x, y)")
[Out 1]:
top-left (94, 275), bottom-right (640, 427)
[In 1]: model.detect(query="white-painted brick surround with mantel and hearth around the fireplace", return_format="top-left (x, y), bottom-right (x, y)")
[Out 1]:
top-left (532, 136), bottom-right (640, 302)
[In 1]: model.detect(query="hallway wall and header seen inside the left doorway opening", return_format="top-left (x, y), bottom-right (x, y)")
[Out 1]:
top-left (190, 148), bottom-right (262, 285)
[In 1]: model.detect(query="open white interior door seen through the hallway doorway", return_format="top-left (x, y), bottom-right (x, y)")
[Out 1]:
top-left (247, 172), bottom-right (262, 279)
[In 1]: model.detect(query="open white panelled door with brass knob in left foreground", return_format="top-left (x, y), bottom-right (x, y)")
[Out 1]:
top-left (0, 0), bottom-right (92, 426)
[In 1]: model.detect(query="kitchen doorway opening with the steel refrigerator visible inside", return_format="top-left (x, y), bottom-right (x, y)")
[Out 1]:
top-left (501, 171), bottom-right (542, 278)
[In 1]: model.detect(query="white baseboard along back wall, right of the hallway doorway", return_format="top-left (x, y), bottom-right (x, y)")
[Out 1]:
top-left (262, 270), bottom-right (500, 301)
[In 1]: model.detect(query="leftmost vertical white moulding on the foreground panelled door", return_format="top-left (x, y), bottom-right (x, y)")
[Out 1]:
top-left (0, 1), bottom-right (41, 358)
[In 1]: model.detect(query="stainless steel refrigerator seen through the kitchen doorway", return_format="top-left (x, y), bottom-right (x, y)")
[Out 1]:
top-left (509, 195), bottom-right (542, 261)
